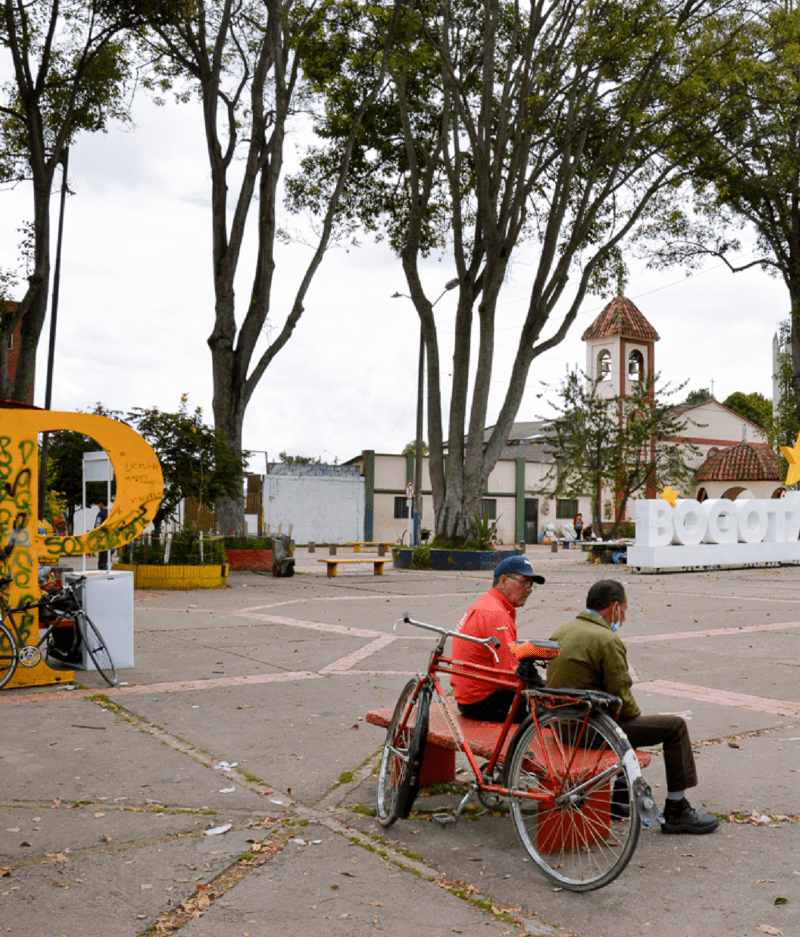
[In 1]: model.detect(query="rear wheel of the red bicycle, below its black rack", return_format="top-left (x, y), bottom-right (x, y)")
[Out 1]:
top-left (506, 706), bottom-right (641, 891)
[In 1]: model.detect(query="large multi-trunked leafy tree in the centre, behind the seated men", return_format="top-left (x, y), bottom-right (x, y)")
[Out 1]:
top-left (289, 0), bottom-right (752, 540)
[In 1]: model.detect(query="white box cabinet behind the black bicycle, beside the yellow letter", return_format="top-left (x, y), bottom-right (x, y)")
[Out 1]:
top-left (65, 570), bottom-right (133, 670)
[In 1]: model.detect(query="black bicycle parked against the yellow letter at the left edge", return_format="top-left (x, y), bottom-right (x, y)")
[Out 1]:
top-left (0, 576), bottom-right (118, 689)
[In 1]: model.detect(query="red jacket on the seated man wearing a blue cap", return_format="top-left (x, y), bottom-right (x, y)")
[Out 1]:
top-left (450, 589), bottom-right (517, 706)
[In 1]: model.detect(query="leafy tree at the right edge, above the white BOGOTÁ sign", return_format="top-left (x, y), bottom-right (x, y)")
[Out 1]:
top-left (655, 0), bottom-right (800, 426)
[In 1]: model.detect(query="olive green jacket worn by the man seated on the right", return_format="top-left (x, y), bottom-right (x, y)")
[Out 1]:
top-left (547, 612), bottom-right (641, 719)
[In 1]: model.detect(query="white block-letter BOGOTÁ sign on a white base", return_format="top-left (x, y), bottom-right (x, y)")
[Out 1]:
top-left (628, 491), bottom-right (800, 569)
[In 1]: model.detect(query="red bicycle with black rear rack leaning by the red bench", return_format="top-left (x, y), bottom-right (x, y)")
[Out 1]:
top-left (377, 614), bottom-right (660, 892)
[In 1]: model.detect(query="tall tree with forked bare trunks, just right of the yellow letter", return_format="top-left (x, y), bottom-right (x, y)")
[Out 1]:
top-left (145, 0), bottom-right (393, 535)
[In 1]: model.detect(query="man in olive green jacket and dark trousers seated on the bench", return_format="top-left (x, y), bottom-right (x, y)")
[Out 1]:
top-left (547, 579), bottom-right (719, 834)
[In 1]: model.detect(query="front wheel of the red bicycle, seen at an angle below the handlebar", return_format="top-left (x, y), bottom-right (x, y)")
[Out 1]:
top-left (377, 678), bottom-right (431, 826)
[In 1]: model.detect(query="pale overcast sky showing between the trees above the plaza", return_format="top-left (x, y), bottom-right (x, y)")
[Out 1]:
top-left (0, 96), bottom-right (788, 471)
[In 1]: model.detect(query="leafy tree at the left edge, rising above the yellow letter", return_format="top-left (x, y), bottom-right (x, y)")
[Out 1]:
top-left (0, 0), bottom-right (188, 402)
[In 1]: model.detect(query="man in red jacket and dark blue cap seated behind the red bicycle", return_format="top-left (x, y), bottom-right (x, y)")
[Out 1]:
top-left (450, 556), bottom-right (544, 722)
